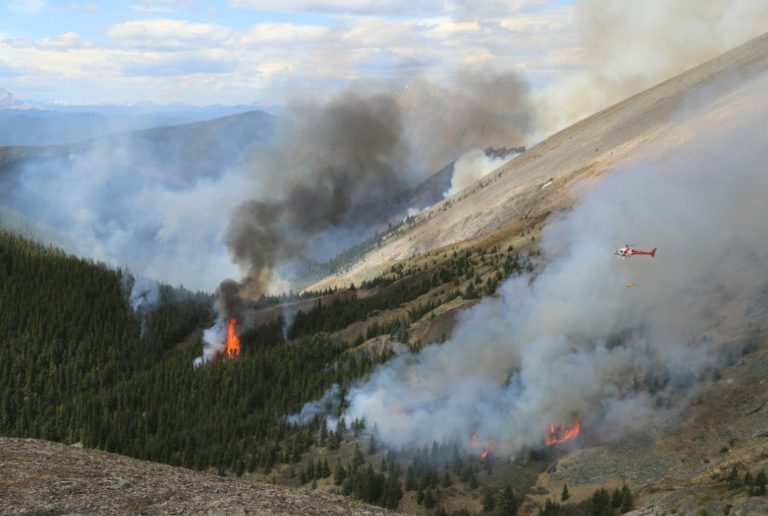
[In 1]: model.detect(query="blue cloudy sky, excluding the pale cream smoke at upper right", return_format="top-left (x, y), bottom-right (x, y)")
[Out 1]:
top-left (0, 0), bottom-right (583, 104)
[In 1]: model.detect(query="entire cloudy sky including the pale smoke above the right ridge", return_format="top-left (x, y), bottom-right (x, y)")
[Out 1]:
top-left (0, 0), bottom-right (768, 113)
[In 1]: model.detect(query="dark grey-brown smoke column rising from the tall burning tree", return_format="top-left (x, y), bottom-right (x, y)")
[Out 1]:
top-left (195, 93), bottom-right (407, 361)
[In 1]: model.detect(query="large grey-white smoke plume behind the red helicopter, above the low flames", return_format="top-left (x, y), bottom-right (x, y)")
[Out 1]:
top-left (346, 81), bottom-right (768, 453)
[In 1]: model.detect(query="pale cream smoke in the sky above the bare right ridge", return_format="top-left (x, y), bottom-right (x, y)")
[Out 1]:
top-left (536, 0), bottom-right (768, 136)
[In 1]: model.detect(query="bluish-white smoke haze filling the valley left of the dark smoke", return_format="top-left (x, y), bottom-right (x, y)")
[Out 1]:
top-left (0, 113), bottom-right (271, 290)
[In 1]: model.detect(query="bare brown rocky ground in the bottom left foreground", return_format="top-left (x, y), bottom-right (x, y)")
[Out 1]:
top-left (0, 437), bottom-right (392, 515)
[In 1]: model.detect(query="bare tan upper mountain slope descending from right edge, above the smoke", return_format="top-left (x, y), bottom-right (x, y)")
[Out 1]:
top-left (309, 31), bottom-right (768, 290)
